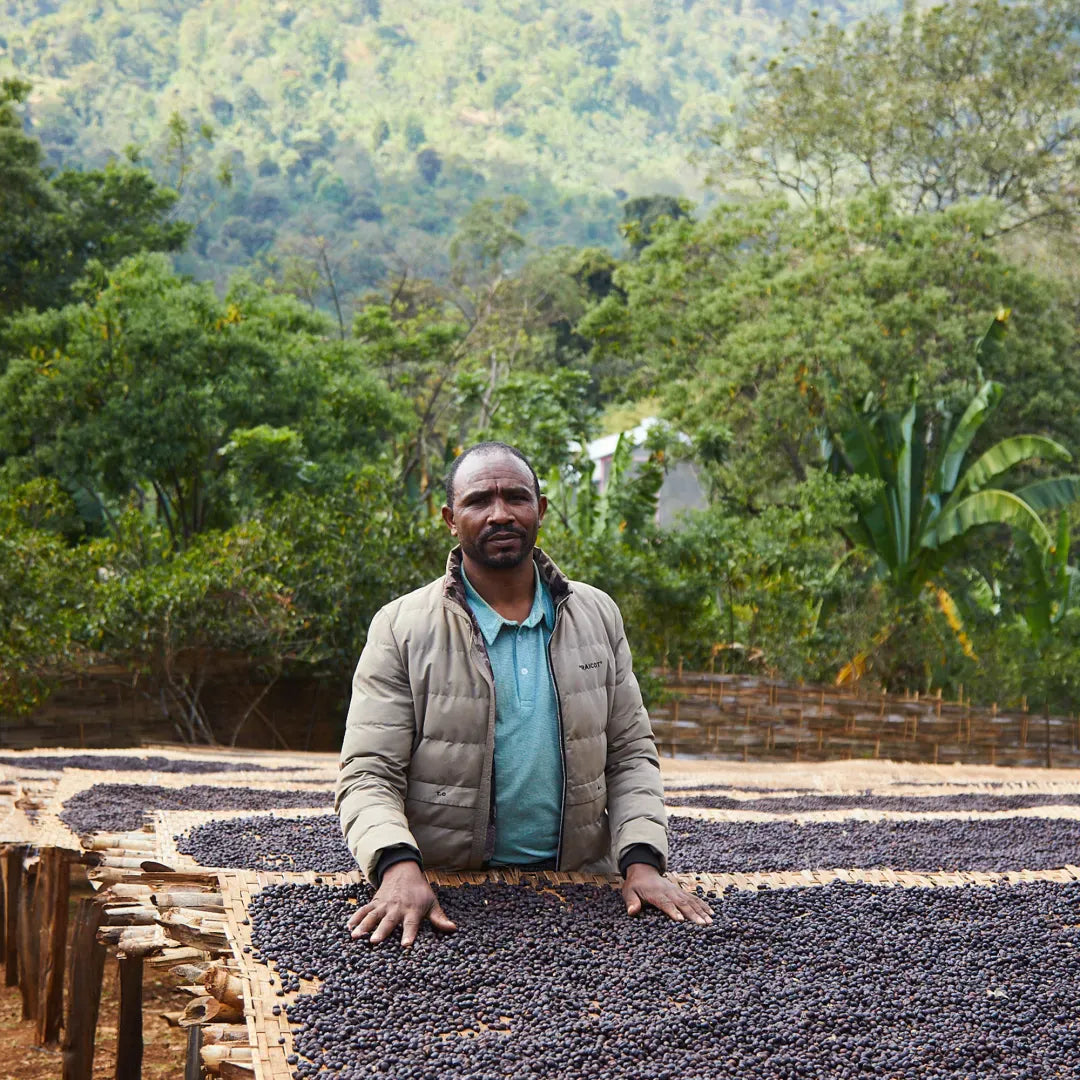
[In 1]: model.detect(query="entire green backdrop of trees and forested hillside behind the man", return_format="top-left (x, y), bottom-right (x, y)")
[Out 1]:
top-left (0, 0), bottom-right (1080, 739)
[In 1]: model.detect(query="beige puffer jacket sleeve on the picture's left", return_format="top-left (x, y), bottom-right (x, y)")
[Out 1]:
top-left (335, 608), bottom-right (419, 882)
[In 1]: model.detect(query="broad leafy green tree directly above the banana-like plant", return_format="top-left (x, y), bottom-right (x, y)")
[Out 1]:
top-left (579, 193), bottom-right (1080, 507)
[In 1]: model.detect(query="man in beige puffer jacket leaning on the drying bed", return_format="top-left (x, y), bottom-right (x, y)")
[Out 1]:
top-left (336, 443), bottom-right (711, 945)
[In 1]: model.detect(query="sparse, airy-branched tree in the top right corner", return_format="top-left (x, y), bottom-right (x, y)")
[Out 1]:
top-left (713, 0), bottom-right (1080, 229)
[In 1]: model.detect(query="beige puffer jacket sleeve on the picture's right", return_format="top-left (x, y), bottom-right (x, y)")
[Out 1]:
top-left (605, 597), bottom-right (667, 873)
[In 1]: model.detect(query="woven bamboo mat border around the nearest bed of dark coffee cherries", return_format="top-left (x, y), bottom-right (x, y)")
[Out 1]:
top-left (218, 866), bottom-right (1080, 1080)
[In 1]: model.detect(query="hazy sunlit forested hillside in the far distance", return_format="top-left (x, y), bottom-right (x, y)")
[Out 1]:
top-left (0, 0), bottom-right (896, 292)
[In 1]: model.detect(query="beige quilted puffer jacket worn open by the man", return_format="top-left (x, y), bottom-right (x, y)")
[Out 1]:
top-left (336, 549), bottom-right (667, 880)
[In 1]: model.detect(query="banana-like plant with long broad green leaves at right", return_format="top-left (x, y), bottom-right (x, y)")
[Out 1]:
top-left (829, 312), bottom-right (1080, 599)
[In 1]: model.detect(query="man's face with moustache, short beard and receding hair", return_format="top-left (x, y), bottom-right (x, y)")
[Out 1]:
top-left (443, 450), bottom-right (548, 570)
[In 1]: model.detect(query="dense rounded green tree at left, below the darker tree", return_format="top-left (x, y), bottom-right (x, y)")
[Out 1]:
top-left (0, 255), bottom-right (403, 544)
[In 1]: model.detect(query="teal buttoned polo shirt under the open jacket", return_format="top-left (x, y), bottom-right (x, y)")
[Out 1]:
top-left (461, 567), bottom-right (563, 865)
